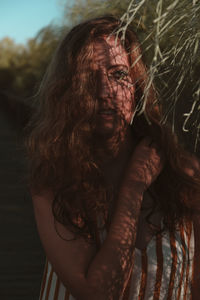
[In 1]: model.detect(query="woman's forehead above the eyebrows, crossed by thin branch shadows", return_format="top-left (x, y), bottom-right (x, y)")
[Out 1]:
top-left (93, 36), bottom-right (129, 66)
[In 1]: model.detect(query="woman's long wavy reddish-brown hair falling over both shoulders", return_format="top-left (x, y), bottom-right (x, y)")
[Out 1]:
top-left (26, 16), bottom-right (200, 246)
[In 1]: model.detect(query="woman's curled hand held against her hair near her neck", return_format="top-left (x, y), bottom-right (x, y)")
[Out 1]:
top-left (125, 137), bottom-right (165, 190)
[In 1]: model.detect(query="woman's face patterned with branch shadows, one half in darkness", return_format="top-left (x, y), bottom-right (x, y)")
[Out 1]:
top-left (93, 36), bottom-right (135, 136)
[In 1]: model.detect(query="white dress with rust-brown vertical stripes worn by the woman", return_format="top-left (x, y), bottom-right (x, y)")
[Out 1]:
top-left (40, 224), bottom-right (194, 300)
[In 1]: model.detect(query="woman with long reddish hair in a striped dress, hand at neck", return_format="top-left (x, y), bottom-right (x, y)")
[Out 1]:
top-left (27, 16), bottom-right (200, 300)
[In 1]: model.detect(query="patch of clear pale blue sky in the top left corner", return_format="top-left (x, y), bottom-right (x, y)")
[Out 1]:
top-left (0, 0), bottom-right (65, 44)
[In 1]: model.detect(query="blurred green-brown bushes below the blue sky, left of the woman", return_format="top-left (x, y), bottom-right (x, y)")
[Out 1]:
top-left (0, 26), bottom-right (66, 97)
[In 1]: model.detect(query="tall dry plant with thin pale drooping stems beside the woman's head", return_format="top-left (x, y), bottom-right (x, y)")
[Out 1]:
top-left (61, 0), bottom-right (200, 154)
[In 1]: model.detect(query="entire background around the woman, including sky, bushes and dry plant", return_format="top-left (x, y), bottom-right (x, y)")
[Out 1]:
top-left (0, 0), bottom-right (200, 300)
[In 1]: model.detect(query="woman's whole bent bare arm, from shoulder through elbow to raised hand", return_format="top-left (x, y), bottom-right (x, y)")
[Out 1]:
top-left (33, 139), bottom-right (163, 300)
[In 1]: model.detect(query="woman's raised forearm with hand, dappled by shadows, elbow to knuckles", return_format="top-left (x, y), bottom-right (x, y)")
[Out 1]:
top-left (86, 138), bottom-right (163, 299)
